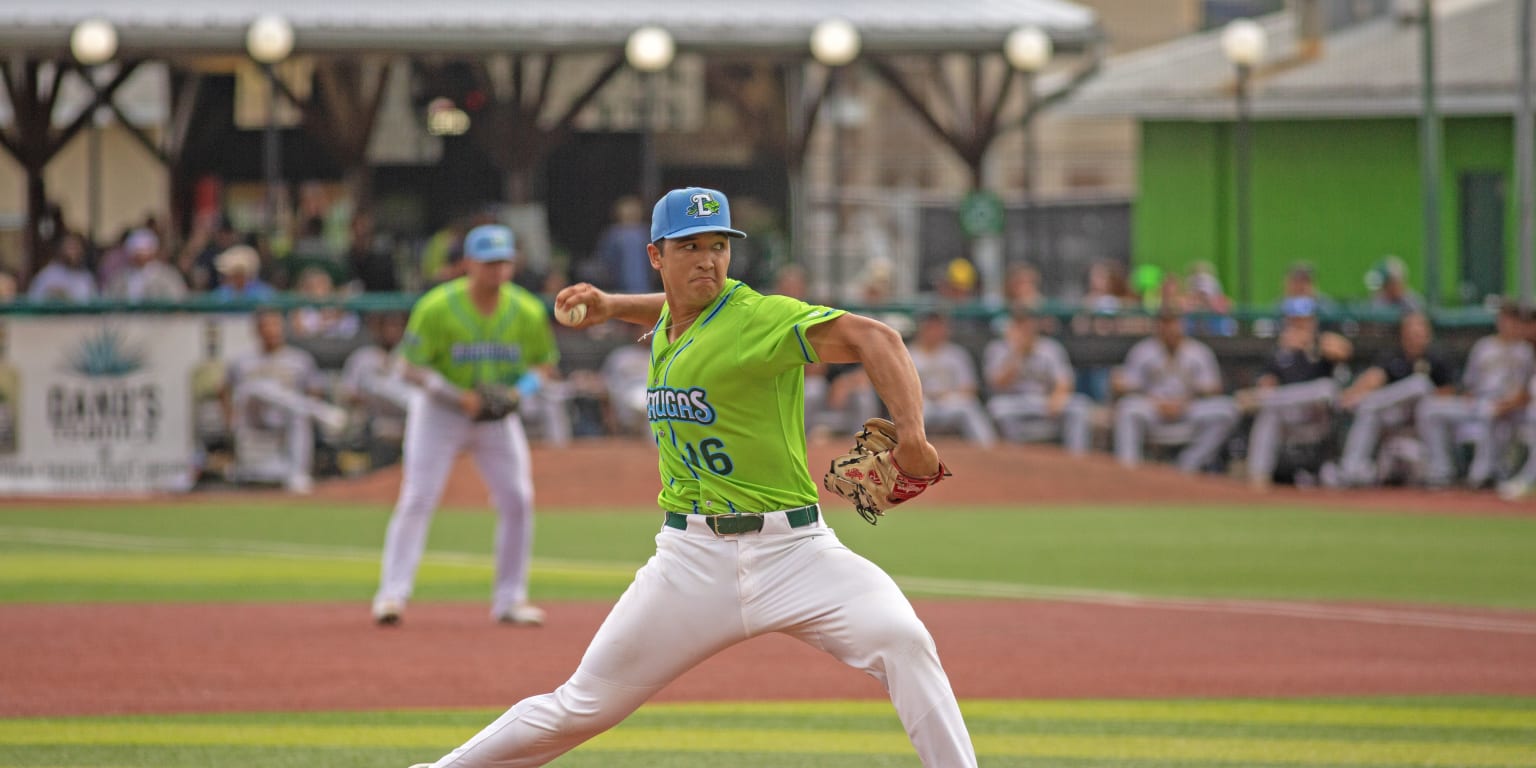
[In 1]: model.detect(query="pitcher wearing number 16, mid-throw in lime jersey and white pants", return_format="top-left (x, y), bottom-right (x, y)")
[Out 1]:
top-left (408, 187), bottom-right (975, 768)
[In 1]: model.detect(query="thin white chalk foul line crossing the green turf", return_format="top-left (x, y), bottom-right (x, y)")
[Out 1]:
top-left (0, 525), bottom-right (1536, 634)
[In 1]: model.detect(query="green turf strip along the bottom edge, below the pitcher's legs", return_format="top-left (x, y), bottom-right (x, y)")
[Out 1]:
top-left (0, 697), bottom-right (1536, 768)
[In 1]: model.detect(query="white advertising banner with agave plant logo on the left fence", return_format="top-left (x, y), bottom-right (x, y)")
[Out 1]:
top-left (0, 315), bottom-right (207, 496)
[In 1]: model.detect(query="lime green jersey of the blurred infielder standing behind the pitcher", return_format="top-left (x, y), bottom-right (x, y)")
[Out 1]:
top-left (401, 278), bottom-right (559, 389)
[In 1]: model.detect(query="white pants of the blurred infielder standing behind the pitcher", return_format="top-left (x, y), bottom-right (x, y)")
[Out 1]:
top-left (373, 392), bottom-right (533, 614)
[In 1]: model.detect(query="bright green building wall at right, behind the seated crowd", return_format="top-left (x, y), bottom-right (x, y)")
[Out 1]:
top-left (1132, 117), bottom-right (1518, 304)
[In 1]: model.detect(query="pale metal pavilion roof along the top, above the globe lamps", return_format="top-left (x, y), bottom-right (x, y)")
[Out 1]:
top-left (0, 0), bottom-right (1101, 57)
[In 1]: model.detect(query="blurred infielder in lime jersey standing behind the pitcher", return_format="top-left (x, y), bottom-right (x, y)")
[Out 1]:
top-left (373, 224), bottom-right (559, 625)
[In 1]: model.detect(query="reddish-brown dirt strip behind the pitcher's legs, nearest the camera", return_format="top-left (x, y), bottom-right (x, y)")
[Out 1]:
top-left (9, 601), bottom-right (1536, 717)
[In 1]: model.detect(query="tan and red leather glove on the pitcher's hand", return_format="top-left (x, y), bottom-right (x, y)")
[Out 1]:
top-left (822, 419), bottom-right (951, 525)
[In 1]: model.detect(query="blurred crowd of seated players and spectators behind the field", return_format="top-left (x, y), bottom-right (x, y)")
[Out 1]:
top-left (0, 198), bottom-right (1536, 498)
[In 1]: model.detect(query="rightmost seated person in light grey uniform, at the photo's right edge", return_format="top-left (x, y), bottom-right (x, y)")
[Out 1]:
top-left (1415, 303), bottom-right (1536, 488)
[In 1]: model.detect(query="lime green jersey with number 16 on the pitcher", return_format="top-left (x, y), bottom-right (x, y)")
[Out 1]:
top-left (647, 280), bottom-right (843, 515)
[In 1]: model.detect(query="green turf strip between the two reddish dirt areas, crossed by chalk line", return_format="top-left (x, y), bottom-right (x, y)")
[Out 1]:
top-left (0, 498), bottom-right (1536, 608)
